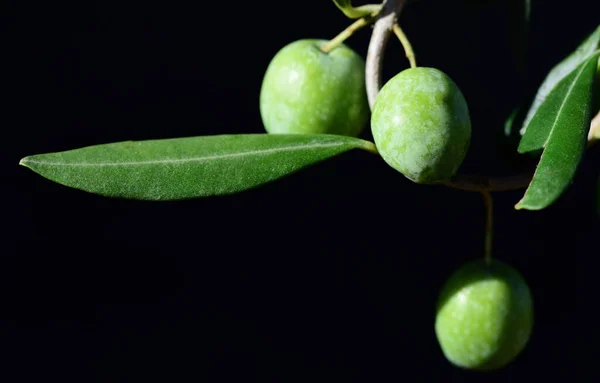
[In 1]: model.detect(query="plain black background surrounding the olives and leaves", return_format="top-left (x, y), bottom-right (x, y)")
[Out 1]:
top-left (0, 0), bottom-right (600, 382)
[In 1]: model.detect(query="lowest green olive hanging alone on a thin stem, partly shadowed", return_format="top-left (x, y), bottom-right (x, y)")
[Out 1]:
top-left (435, 260), bottom-right (533, 371)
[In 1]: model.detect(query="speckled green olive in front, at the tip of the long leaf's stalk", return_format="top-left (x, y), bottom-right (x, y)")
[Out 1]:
top-left (371, 67), bottom-right (471, 184)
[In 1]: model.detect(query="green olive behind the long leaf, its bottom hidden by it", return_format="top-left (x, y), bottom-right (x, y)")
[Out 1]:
top-left (260, 39), bottom-right (370, 137)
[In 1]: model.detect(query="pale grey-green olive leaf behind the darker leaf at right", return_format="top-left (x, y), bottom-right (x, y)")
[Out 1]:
top-left (520, 25), bottom-right (600, 135)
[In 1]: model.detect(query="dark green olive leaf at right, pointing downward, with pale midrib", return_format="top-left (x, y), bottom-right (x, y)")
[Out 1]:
top-left (515, 51), bottom-right (600, 210)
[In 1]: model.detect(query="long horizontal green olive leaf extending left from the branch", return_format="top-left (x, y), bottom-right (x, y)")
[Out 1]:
top-left (20, 134), bottom-right (377, 201)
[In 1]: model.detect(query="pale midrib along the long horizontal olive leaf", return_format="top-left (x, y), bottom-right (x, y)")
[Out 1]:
top-left (20, 142), bottom-right (345, 167)
